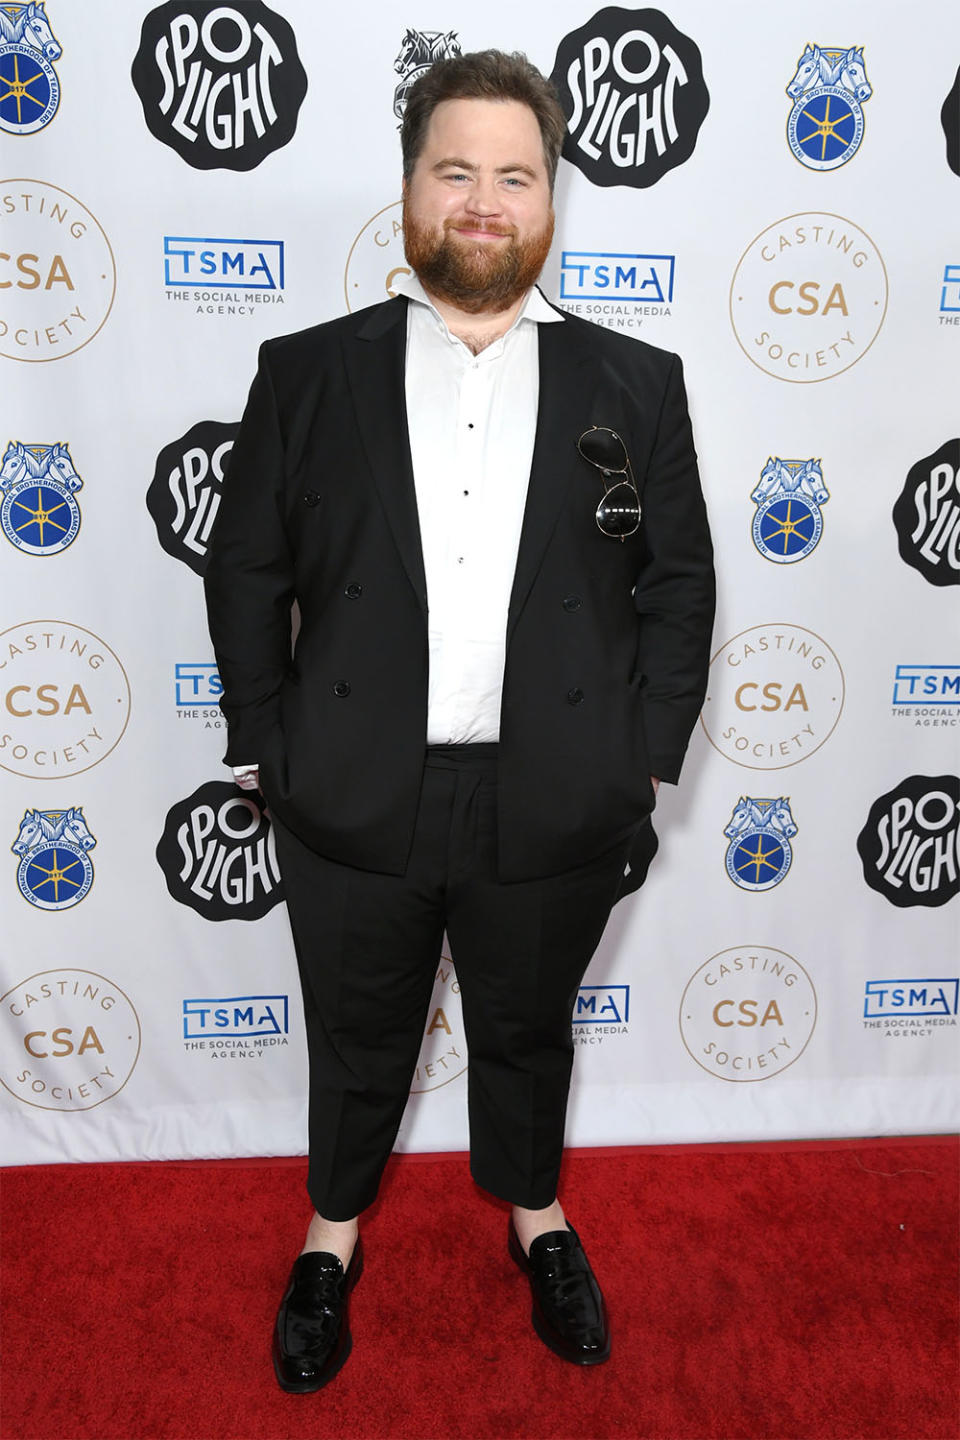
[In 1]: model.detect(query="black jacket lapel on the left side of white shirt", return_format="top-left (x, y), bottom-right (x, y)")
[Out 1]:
top-left (344, 300), bottom-right (426, 615)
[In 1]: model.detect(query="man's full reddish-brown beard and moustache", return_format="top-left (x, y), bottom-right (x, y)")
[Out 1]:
top-left (403, 196), bottom-right (554, 315)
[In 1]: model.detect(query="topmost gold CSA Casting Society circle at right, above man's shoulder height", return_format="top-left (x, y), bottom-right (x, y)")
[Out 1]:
top-left (730, 212), bottom-right (887, 384)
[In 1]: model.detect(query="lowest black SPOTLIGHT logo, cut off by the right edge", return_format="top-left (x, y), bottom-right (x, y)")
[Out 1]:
top-left (856, 775), bottom-right (960, 909)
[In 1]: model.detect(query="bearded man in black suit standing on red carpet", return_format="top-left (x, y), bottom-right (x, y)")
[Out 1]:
top-left (206, 50), bottom-right (712, 1392)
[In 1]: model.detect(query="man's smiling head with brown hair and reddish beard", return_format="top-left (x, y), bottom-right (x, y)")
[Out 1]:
top-left (400, 50), bottom-right (566, 314)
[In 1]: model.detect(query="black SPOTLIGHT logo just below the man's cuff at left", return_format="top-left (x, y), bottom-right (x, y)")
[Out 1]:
top-left (157, 780), bottom-right (284, 920)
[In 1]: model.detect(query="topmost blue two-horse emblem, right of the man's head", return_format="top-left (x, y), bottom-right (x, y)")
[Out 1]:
top-left (787, 45), bottom-right (874, 170)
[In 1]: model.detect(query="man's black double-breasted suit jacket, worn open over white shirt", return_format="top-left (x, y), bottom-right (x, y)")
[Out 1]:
top-left (206, 298), bottom-right (714, 890)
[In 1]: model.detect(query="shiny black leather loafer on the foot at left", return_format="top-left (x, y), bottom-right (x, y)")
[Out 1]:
top-left (273, 1236), bottom-right (363, 1395)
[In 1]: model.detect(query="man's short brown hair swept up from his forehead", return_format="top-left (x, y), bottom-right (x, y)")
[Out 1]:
top-left (400, 50), bottom-right (567, 192)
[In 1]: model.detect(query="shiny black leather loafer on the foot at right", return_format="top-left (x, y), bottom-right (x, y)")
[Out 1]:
top-left (508, 1218), bottom-right (610, 1365)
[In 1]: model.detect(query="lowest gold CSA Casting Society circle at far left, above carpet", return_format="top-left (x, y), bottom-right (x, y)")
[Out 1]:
top-left (0, 969), bottom-right (140, 1110)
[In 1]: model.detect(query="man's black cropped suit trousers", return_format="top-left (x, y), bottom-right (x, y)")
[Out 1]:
top-left (275, 744), bottom-right (630, 1220)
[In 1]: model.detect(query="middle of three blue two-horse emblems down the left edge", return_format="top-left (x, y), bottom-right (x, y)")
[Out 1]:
top-left (0, 441), bottom-right (83, 554)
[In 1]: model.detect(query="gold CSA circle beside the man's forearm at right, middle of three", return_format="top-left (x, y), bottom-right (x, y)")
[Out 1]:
top-left (701, 625), bottom-right (843, 770)
